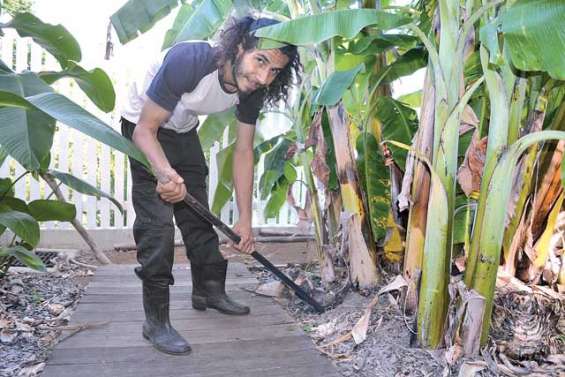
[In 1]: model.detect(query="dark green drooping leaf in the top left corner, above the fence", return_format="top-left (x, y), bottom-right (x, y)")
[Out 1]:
top-left (0, 13), bottom-right (82, 67)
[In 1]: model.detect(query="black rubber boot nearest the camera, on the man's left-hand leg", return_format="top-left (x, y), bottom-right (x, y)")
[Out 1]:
top-left (143, 282), bottom-right (192, 355)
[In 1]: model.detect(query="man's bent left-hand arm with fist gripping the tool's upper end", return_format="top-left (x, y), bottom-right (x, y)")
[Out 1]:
top-left (132, 99), bottom-right (186, 203)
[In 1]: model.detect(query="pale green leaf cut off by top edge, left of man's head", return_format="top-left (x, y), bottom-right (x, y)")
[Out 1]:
top-left (110, 0), bottom-right (179, 44)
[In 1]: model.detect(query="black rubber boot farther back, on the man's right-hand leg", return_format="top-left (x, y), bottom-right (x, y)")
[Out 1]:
top-left (191, 261), bottom-right (249, 315)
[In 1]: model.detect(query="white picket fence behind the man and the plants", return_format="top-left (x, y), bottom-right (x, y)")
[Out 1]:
top-left (0, 30), bottom-right (304, 229)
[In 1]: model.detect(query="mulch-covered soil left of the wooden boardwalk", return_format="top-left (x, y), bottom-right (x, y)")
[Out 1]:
top-left (0, 263), bottom-right (94, 377)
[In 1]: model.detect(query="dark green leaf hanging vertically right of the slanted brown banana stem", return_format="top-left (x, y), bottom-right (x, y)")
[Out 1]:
top-left (357, 132), bottom-right (391, 241)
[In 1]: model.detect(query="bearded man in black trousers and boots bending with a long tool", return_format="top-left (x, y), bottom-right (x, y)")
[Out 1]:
top-left (121, 17), bottom-right (301, 354)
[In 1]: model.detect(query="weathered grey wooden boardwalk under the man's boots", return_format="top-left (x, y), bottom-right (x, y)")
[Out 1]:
top-left (42, 263), bottom-right (339, 377)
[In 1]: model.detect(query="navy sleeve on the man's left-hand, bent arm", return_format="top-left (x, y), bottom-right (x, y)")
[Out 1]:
top-left (146, 43), bottom-right (214, 112)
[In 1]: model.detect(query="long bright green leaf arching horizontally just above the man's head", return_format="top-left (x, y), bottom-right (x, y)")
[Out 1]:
top-left (256, 9), bottom-right (412, 48)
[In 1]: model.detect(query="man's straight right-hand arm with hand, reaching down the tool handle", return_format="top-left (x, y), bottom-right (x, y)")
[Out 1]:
top-left (233, 122), bottom-right (255, 253)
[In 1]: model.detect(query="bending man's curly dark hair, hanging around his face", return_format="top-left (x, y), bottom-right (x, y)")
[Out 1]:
top-left (213, 16), bottom-right (302, 106)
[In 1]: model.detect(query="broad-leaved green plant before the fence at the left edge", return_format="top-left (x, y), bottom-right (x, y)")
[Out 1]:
top-left (0, 13), bottom-right (149, 272)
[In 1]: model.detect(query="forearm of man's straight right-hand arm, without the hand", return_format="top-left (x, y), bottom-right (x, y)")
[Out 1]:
top-left (233, 149), bottom-right (253, 224)
